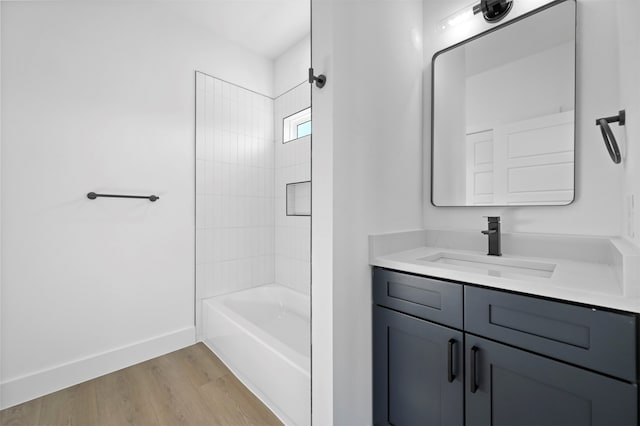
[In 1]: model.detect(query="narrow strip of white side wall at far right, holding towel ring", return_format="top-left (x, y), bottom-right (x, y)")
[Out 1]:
top-left (612, 0), bottom-right (640, 246)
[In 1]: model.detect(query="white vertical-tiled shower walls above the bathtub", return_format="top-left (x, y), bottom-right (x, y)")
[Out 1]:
top-left (196, 73), bottom-right (311, 330)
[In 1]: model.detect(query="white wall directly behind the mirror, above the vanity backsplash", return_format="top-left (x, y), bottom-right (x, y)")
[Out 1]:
top-left (423, 0), bottom-right (622, 235)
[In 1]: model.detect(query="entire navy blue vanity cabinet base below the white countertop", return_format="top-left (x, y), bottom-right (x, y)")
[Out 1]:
top-left (373, 268), bottom-right (640, 426)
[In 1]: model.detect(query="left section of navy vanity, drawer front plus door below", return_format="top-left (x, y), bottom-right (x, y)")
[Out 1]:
top-left (373, 269), bottom-right (464, 426)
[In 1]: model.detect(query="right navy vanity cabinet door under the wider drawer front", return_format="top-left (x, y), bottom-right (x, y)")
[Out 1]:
top-left (465, 334), bottom-right (638, 426)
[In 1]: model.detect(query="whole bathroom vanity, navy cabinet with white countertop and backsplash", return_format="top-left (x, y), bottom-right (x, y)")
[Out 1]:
top-left (369, 230), bottom-right (640, 426)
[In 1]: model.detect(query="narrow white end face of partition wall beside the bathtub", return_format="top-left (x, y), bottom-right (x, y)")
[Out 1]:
top-left (311, 0), bottom-right (338, 425)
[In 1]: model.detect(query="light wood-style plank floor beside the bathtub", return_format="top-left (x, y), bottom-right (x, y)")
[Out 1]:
top-left (0, 343), bottom-right (282, 426)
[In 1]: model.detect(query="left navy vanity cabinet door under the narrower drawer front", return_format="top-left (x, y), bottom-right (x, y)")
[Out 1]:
top-left (373, 306), bottom-right (464, 426)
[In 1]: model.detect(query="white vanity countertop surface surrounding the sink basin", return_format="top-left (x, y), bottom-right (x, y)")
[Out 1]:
top-left (370, 231), bottom-right (640, 313)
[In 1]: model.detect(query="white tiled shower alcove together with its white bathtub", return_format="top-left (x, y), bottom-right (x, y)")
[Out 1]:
top-left (196, 72), bottom-right (311, 424)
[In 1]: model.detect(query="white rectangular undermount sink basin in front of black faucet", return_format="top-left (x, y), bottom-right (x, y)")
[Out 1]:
top-left (417, 252), bottom-right (556, 278)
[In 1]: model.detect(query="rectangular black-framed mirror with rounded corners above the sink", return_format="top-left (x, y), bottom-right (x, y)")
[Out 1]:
top-left (431, 0), bottom-right (576, 206)
